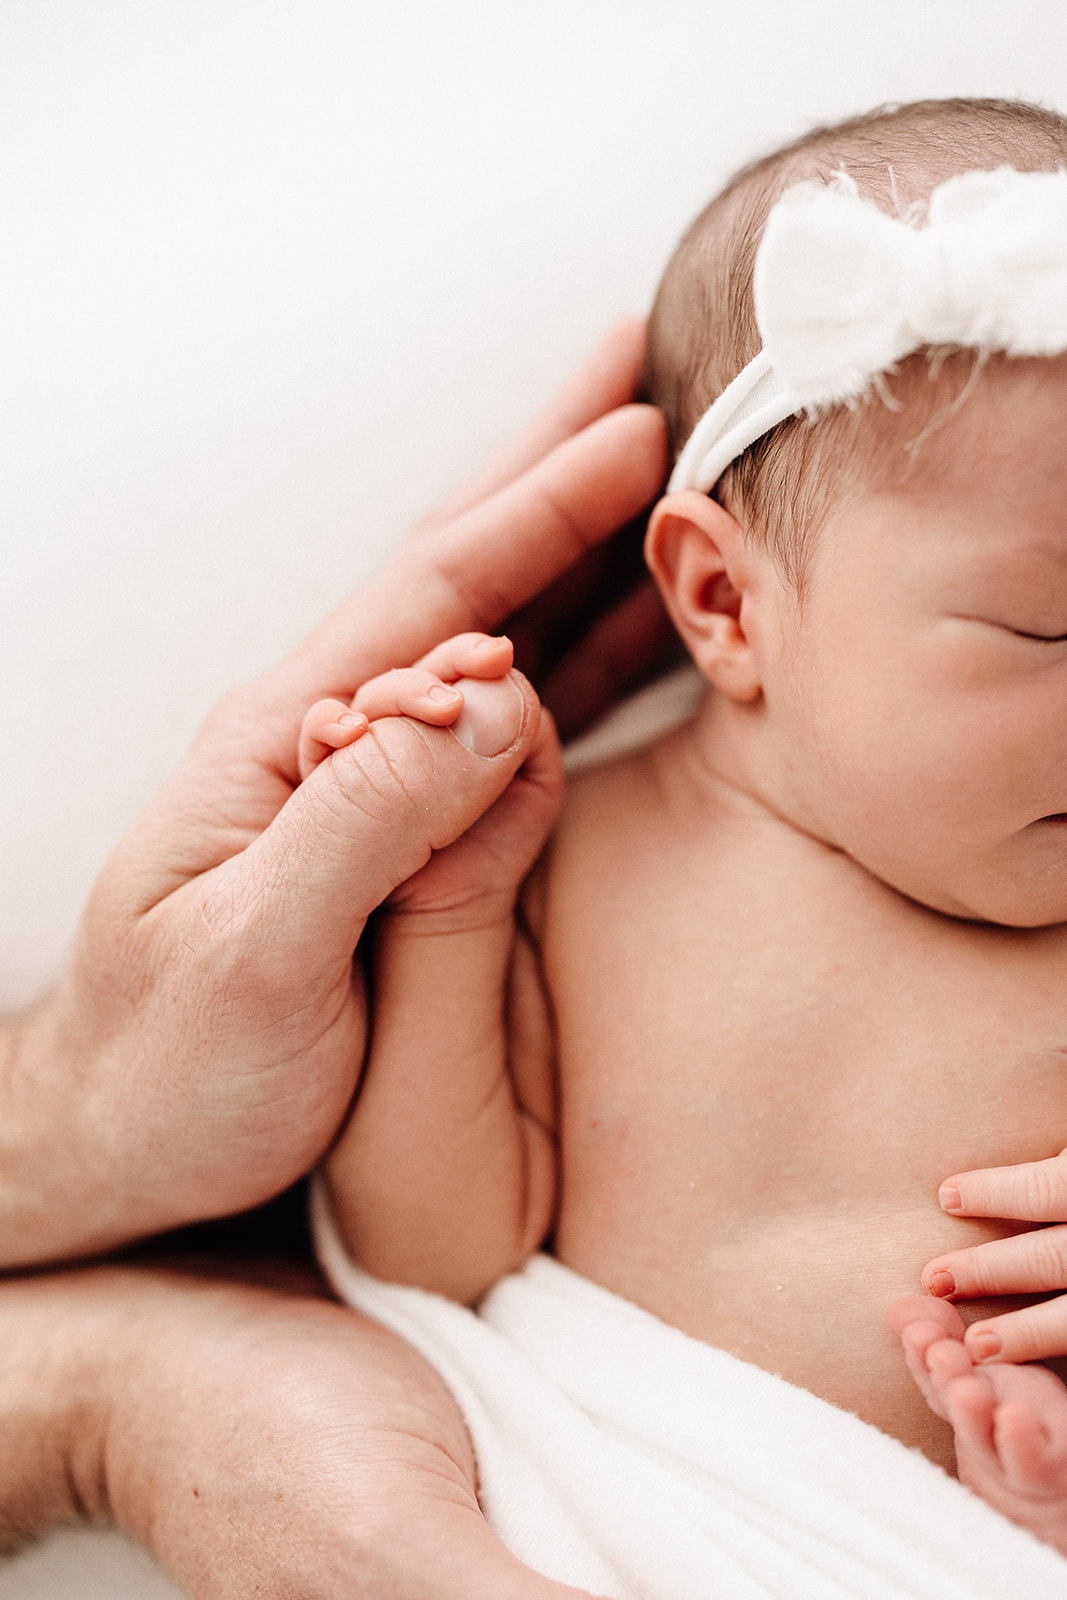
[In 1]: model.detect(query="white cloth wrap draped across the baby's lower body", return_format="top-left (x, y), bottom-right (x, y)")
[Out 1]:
top-left (315, 1187), bottom-right (1067, 1600)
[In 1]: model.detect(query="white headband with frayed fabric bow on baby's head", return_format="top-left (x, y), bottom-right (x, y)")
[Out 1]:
top-left (667, 166), bottom-right (1067, 493)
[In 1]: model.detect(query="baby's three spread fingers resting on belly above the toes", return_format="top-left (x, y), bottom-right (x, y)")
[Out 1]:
top-left (921, 1150), bottom-right (1067, 1362)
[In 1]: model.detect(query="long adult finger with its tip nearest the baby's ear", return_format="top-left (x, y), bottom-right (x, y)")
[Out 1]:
top-left (268, 405), bottom-right (667, 715)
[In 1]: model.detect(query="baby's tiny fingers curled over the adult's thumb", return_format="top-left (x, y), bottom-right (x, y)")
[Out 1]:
top-left (298, 634), bottom-right (514, 781)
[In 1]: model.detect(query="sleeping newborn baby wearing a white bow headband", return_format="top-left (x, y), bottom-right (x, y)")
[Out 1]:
top-left (302, 102), bottom-right (1067, 1550)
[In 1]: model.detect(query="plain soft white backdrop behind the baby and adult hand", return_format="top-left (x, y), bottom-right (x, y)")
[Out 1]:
top-left (0, 0), bottom-right (1067, 1600)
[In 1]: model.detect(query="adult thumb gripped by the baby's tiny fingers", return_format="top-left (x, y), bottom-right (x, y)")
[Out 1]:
top-left (227, 672), bottom-right (541, 966)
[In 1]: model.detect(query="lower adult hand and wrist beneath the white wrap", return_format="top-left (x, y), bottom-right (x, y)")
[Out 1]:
top-left (0, 1267), bottom-right (601, 1600)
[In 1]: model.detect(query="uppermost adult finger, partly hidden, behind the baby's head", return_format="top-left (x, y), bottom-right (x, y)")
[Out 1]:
top-left (414, 317), bottom-right (645, 538)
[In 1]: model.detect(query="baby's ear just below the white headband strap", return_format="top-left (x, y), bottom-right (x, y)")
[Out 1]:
top-left (645, 490), bottom-right (763, 701)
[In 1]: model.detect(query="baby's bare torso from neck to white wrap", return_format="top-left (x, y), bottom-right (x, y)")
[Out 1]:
top-left (544, 732), bottom-right (1067, 1467)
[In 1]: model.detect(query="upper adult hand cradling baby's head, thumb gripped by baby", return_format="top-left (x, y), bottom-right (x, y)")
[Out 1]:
top-left (0, 326), bottom-right (665, 1267)
